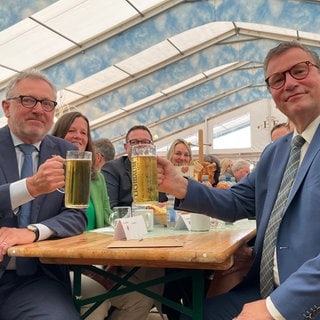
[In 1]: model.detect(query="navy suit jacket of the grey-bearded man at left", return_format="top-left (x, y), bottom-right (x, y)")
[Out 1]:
top-left (0, 126), bottom-right (87, 281)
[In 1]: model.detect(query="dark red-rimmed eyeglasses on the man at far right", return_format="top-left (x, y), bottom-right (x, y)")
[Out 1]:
top-left (265, 61), bottom-right (319, 89)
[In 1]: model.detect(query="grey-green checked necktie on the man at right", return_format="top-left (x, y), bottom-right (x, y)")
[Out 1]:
top-left (260, 135), bottom-right (305, 298)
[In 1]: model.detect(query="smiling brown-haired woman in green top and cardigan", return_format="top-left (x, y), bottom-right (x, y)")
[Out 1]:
top-left (52, 111), bottom-right (111, 230)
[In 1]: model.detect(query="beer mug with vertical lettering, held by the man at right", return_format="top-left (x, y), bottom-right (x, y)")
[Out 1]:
top-left (131, 144), bottom-right (158, 206)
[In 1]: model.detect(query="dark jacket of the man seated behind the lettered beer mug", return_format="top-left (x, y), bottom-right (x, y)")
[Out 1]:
top-left (101, 156), bottom-right (168, 208)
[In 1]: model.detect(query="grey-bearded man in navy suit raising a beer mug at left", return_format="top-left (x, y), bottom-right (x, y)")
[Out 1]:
top-left (0, 71), bottom-right (87, 320)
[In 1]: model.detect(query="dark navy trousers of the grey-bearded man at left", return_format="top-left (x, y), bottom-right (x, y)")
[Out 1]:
top-left (0, 271), bottom-right (81, 320)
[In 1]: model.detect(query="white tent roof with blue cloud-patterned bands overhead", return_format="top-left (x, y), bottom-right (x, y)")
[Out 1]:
top-left (0, 0), bottom-right (320, 158)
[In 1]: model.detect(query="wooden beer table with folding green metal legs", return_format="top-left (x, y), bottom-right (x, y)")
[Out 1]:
top-left (8, 220), bottom-right (255, 319)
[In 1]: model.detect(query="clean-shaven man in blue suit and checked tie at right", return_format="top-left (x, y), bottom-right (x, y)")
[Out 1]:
top-left (158, 42), bottom-right (320, 320)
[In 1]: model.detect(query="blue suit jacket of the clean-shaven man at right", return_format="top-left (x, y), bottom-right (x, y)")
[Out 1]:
top-left (180, 128), bottom-right (320, 319)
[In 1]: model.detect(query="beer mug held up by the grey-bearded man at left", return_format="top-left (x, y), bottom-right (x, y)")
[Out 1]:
top-left (64, 150), bottom-right (92, 208)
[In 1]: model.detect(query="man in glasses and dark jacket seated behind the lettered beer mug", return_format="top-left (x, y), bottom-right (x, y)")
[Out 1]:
top-left (101, 125), bottom-right (164, 320)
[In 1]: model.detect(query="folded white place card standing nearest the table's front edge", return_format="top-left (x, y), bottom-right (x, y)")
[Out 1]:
top-left (114, 216), bottom-right (148, 240)
